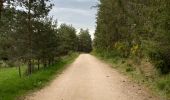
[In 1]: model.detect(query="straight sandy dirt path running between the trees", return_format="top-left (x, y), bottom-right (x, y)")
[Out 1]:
top-left (26, 54), bottom-right (160, 100)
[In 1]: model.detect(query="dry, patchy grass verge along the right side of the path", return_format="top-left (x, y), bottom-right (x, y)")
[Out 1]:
top-left (92, 51), bottom-right (170, 100)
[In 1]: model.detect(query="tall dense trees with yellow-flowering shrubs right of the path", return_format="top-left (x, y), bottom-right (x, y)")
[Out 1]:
top-left (94, 0), bottom-right (170, 74)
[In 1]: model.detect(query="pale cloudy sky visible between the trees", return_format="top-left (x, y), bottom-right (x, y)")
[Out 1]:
top-left (50, 0), bottom-right (98, 38)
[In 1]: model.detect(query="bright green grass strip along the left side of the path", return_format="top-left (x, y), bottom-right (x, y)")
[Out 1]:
top-left (0, 53), bottom-right (78, 100)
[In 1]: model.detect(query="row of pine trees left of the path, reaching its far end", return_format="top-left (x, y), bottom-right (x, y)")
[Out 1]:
top-left (0, 0), bottom-right (92, 74)
